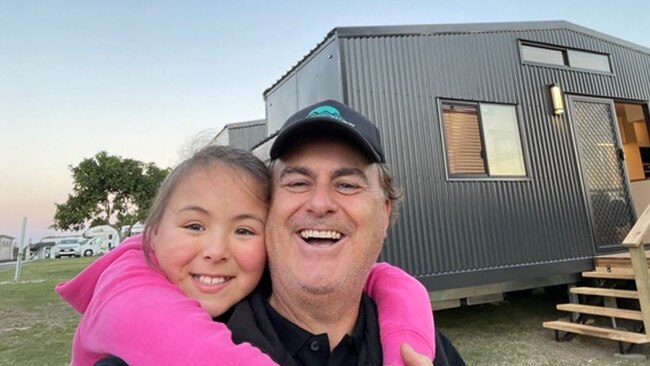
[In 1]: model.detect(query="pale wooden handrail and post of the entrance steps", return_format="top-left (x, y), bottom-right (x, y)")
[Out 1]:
top-left (623, 205), bottom-right (650, 337)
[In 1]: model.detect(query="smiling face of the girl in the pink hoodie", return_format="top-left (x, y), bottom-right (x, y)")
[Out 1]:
top-left (151, 162), bottom-right (268, 317)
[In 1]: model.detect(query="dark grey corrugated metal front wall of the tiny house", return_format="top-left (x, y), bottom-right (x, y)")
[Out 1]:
top-left (339, 29), bottom-right (650, 285)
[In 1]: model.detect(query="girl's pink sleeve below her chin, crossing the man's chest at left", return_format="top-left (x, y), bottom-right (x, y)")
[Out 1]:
top-left (75, 251), bottom-right (275, 365)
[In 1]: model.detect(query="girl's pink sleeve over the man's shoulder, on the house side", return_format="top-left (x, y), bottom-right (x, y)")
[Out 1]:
top-left (364, 263), bottom-right (435, 365)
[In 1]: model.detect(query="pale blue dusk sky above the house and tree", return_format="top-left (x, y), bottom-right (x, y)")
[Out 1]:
top-left (0, 0), bottom-right (650, 242)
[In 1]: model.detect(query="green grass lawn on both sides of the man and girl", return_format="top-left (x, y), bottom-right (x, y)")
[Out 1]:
top-left (0, 258), bottom-right (650, 366)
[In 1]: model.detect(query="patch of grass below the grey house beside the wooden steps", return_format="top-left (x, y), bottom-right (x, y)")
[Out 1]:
top-left (435, 291), bottom-right (650, 366)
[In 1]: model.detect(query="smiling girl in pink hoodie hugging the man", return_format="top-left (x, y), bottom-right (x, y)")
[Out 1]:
top-left (56, 146), bottom-right (434, 365)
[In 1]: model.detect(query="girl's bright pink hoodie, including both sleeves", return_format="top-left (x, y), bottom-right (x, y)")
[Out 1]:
top-left (56, 236), bottom-right (435, 365)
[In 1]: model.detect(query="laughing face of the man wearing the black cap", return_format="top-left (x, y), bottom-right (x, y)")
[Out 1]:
top-left (266, 139), bottom-right (391, 295)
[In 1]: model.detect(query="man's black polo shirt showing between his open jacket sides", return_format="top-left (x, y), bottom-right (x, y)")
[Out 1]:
top-left (264, 295), bottom-right (374, 366)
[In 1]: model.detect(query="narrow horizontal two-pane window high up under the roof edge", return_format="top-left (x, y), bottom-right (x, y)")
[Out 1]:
top-left (521, 43), bottom-right (612, 73)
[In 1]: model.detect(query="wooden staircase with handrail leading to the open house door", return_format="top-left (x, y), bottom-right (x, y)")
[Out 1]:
top-left (543, 206), bottom-right (650, 353)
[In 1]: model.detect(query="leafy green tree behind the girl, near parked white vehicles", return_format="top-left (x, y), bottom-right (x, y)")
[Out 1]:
top-left (51, 151), bottom-right (169, 231)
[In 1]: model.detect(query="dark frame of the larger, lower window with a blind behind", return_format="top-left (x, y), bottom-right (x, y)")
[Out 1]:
top-left (437, 98), bottom-right (532, 181)
